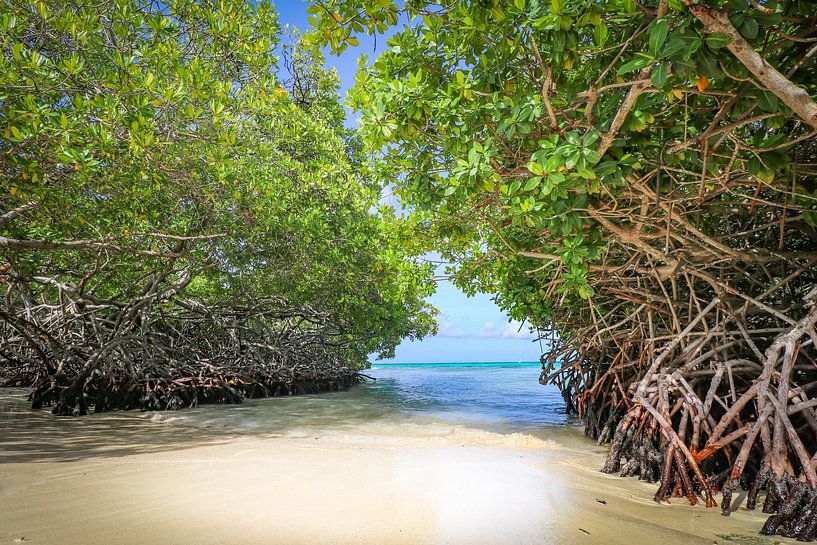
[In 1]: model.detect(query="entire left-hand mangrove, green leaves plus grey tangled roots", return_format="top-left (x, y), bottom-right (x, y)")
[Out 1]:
top-left (0, 0), bottom-right (433, 413)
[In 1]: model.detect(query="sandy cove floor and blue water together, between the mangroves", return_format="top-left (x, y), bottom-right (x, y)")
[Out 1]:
top-left (0, 364), bottom-right (776, 545)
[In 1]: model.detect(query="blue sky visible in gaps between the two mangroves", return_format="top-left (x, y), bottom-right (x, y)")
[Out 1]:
top-left (276, 0), bottom-right (540, 363)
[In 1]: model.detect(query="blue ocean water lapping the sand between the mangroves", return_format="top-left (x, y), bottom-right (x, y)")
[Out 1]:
top-left (145, 362), bottom-right (577, 439)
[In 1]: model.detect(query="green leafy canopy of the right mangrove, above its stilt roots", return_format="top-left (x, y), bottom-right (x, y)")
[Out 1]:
top-left (311, 0), bottom-right (817, 332)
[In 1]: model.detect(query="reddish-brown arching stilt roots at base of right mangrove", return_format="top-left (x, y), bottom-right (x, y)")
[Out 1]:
top-left (541, 292), bottom-right (817, 541)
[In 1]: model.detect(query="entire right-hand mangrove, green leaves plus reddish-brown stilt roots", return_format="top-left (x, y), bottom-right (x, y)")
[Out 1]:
top-left (311, 0), bottom-right (817, 540)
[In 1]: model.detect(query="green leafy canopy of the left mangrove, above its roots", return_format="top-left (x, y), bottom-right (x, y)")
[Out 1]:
top-left (0, 0), bottom-right (440, 365)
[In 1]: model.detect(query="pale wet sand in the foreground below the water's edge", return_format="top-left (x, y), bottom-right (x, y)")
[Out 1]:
top-left (0, 396), bottom-right (793, 545)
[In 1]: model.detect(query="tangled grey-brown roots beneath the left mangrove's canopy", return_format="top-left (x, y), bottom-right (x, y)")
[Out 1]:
top-left (0, 274), bottom-right (364, 416)
